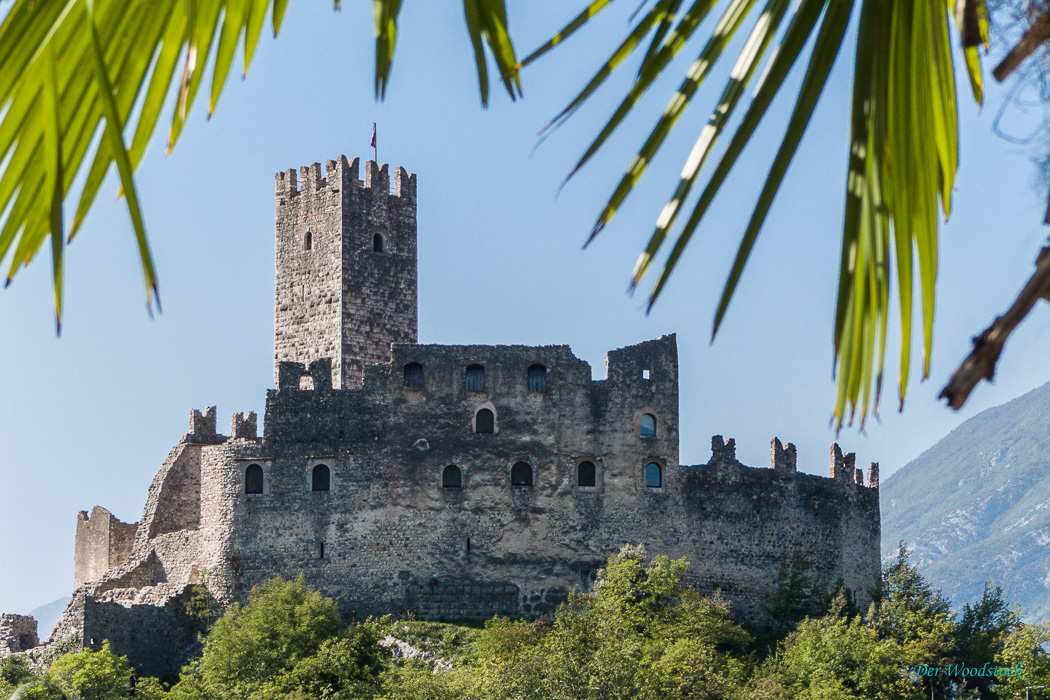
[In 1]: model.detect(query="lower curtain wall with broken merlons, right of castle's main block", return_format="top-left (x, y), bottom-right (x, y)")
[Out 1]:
top-left (669, 437), bottom-right (881, 620)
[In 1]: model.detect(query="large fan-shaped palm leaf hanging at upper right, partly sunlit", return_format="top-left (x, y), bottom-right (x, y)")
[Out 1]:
top-left (525, 0), bottom-right (987, 428)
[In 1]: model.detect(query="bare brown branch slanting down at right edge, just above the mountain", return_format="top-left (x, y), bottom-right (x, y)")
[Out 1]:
top-left (938, 246), bottom-right (1050, 410)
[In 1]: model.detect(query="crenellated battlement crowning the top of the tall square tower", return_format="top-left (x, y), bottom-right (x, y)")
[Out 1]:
top-left (274, 155), bottom-right (416, 201)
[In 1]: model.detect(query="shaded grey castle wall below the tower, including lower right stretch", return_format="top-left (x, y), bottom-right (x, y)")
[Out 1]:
top-left (197, 336), bottom-right (879, 620)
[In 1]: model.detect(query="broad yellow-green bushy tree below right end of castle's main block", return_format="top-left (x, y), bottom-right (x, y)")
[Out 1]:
top-left (460, 548), bottom-right (748, 700)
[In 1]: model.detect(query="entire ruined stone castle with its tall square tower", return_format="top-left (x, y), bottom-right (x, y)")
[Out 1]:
top-left (0, 156), bottom-right (880, 675)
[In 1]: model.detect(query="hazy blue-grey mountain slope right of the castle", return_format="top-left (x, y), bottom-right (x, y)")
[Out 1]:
top-left (880, 383), bottom-right (1050, 620)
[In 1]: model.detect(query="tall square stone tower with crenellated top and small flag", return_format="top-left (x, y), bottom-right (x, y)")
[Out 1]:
top-left (274, 156), bottom-right (418, 388)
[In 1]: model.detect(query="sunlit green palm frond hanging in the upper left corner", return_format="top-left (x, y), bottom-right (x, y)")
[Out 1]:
top-left (0, 0), bottom-right (287, 323)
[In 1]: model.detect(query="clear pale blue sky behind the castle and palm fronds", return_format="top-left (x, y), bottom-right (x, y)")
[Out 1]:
top-left (0, 1), bottom-right (1050, 612)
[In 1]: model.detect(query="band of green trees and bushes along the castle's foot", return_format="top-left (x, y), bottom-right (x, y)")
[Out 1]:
top-left (0, 548), bottom-right (1050, 700)
